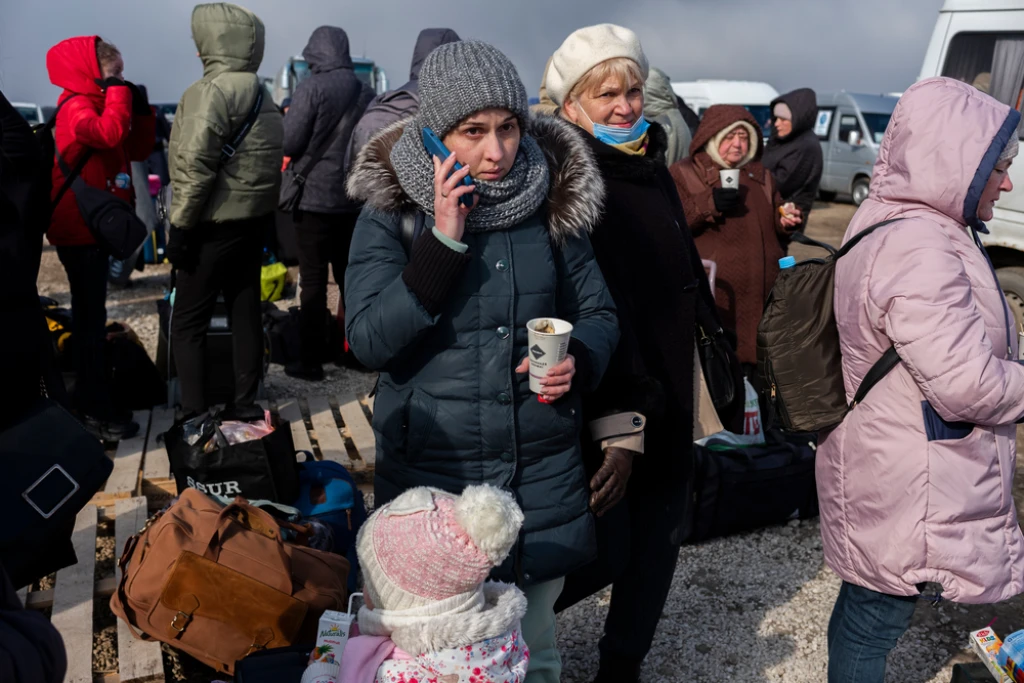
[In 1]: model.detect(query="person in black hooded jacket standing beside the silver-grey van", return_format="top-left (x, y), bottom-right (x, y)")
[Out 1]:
top-left (761, 88), bottom-right (823, 231)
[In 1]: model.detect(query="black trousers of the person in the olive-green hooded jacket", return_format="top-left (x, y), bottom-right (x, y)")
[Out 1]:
top-left (171, 214), bottom-right (264, 413)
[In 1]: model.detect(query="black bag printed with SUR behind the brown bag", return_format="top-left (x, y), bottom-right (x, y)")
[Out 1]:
top-left (164, 413), bottom-right (299, 505)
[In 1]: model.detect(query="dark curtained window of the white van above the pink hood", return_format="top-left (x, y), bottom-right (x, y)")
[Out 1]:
top-left (942, 33), bottom-right (1024, 136)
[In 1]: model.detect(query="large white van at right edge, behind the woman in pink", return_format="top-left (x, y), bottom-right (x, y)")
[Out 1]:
top-left (921, 0), bottom-right (1024, 325)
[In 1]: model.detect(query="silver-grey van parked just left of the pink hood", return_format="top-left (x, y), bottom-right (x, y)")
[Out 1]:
top-left (814, 91), bottom-right (899, 206)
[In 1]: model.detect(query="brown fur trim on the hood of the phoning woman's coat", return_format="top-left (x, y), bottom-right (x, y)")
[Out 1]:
top-left (346, 117), bottom-right (604, 244)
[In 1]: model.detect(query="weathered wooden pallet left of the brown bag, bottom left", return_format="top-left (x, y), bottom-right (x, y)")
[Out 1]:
top-left (19, 497), bottom-right (165, 683)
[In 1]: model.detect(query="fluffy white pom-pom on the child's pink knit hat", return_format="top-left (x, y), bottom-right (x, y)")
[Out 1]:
top-left (455, 484), bottom-right (523, 565)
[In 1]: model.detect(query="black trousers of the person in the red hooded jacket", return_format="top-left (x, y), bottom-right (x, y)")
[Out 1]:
top-left (57, 245), bottom-right (115, 420)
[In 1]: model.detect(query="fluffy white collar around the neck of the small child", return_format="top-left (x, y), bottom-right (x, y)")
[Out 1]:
top-left (359, 582), bottom-right (526, 654)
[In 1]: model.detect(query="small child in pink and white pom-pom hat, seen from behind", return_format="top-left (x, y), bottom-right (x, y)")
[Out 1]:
top-left (340, 485), bottom-right (529, 683)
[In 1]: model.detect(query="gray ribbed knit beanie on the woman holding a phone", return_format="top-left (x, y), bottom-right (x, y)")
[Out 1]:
top-left (419, 40), bottom-right (529, 137)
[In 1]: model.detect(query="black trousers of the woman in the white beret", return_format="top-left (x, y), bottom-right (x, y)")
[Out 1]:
top-left (555, 443), bottom-right (689, 667)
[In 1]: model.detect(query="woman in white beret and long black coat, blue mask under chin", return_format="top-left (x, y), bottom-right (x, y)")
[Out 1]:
top-left (547, 25), bottom-right (742, 683)
